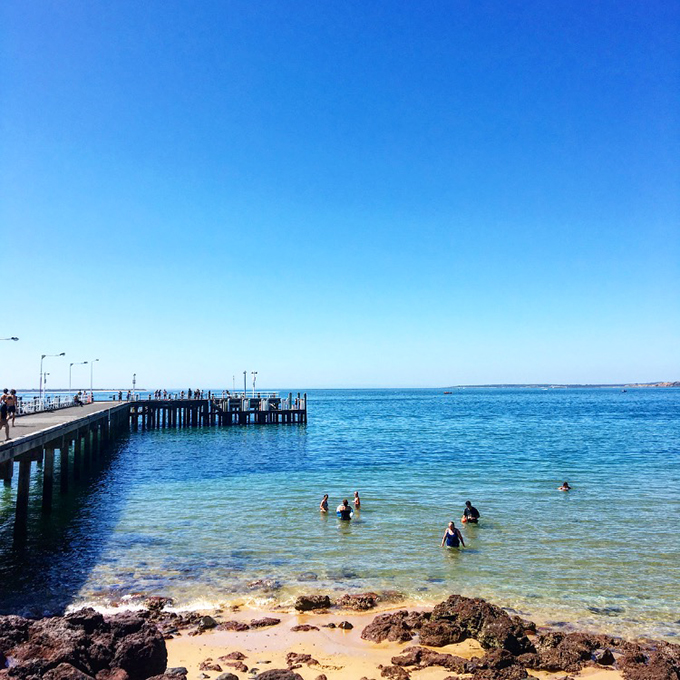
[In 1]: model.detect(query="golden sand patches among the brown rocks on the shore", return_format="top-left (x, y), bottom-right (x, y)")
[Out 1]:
top-left (162, 607), bottom-right (623, 680)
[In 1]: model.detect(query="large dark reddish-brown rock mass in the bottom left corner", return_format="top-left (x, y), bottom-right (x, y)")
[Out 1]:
top-left (0, 609), bottom-right (167, 680)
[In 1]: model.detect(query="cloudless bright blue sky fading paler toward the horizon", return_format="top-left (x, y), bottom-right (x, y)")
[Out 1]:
top-left (0, 0), bottom-right (680, 388)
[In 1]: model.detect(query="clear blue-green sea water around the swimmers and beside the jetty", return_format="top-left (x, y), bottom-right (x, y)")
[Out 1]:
top-left (0, 388), bottom-right (680, 639)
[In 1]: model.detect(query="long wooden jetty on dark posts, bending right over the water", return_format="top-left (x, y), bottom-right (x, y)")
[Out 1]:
top-left (0, 393), bottom-right (307, 541)
